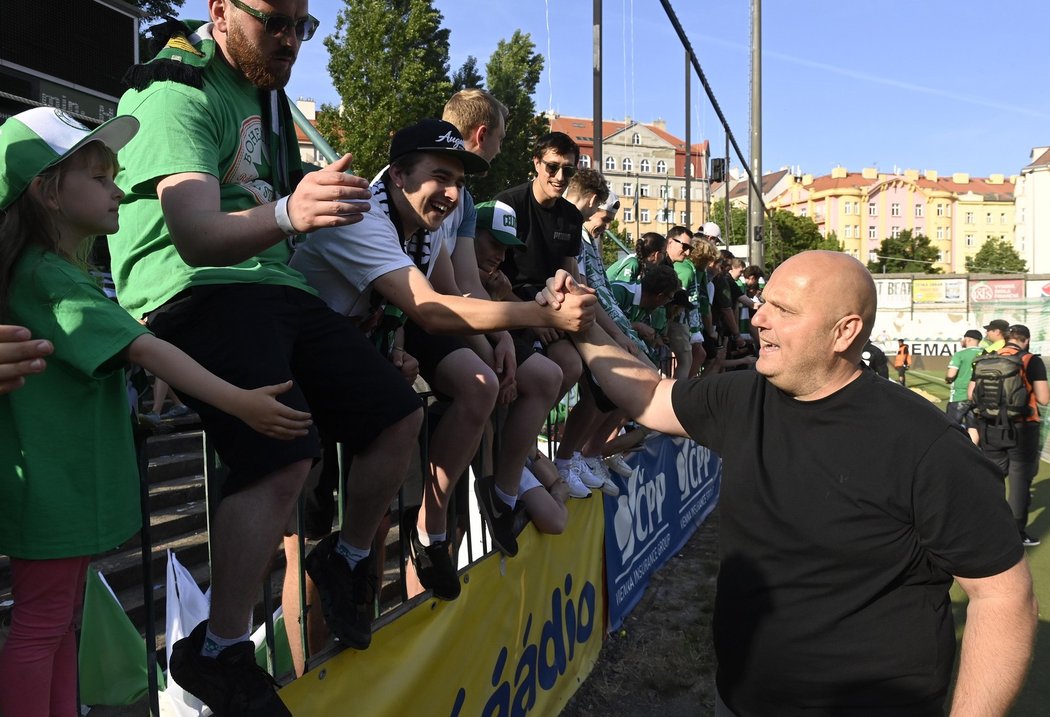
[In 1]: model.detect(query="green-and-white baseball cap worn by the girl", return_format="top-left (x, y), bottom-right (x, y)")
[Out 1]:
top-left (0, 107), bottom-right (139, 210)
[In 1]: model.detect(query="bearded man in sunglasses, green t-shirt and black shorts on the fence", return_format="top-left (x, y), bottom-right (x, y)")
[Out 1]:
top-left (104, 0), bottom-right (422, 717)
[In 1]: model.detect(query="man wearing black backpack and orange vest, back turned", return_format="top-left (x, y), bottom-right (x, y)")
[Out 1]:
top-left (969, 323), bottom-right (1050, 547)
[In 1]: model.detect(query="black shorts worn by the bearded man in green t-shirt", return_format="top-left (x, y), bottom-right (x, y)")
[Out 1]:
top-left (149, 283), bottom-right (421, 494)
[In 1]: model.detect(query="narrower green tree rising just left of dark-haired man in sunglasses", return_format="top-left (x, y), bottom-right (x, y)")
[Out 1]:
top-left (469, 30), bottom-right (547, 201)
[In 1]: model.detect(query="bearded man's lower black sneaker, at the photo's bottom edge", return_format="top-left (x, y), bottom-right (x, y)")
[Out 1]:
top-left (168, 623), bottom-right (292, 717)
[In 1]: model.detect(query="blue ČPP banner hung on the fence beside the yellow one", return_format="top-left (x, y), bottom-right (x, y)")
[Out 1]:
top-left (605, 434), bottom-right (721, 631)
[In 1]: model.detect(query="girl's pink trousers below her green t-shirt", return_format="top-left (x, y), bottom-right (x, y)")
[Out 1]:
top-left (0, 556), bottom-right (90, 717)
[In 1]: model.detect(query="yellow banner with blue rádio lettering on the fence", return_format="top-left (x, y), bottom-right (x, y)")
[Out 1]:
top-left (280, 493), bottom-right (605, 717)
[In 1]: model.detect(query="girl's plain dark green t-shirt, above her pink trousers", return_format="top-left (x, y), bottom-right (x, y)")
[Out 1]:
top-left (0, 247), bottom-right (147, 560)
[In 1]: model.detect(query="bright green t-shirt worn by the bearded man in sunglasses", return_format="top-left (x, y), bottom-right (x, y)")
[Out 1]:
top-left (109, 53), bottom-right (313, 317)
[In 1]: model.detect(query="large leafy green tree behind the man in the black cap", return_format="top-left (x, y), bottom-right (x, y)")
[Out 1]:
top-left (317, 0), bottom-right (452, 178)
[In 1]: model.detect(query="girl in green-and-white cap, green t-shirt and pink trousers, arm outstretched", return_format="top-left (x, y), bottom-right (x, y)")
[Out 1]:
top-left (0, 107), bottom-right (310, 717)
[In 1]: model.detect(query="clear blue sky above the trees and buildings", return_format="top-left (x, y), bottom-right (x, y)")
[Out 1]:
top-left (289, 0), bottom-right (1050, 176)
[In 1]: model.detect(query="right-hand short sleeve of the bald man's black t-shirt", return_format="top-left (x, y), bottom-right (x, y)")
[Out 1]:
top-left (914, 426), bottom-right (1024, 577)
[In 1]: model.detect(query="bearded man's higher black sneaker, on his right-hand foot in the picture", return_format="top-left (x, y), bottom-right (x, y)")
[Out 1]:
top-left (306, 532), bottom-right (379, 650)
